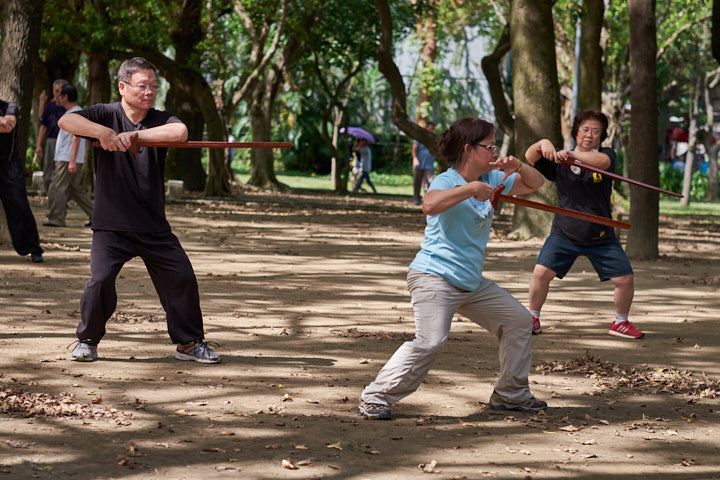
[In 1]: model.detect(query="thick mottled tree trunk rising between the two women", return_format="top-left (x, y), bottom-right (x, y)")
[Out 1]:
top-left (510, 0), bottom-right (563, 237)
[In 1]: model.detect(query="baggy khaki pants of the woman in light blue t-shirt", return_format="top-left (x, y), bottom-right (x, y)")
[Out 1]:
top-left (360, 269), bottom-right (532, 405)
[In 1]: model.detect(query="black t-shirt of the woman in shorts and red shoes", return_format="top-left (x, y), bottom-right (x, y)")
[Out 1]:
top-left (535, 148), bottom-right (616, 245)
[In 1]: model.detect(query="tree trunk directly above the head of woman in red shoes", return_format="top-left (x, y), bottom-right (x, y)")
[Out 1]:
top-left (577, 0), bottom-right (605, 112)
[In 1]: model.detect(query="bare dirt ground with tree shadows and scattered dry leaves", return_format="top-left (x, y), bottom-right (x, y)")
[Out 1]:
top-left (0, 188), bottom-right (720, 480)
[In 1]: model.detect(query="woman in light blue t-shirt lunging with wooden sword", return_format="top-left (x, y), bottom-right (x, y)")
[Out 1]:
top-left (359, 118), bottom-right (547, 419)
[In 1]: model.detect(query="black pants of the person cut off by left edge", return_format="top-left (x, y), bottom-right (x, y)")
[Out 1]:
top-left (0, 158), bottom-right (43, 255)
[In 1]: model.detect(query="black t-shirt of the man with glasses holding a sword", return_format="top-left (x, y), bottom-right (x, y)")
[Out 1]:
top-left (76, 102), bottom-right (182, 233)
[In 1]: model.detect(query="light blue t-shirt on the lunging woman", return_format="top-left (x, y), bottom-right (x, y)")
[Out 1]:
top-left (410, 168), bottom-right (515, 291)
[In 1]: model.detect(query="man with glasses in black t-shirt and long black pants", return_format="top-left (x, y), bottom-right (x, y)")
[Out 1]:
top-left (60, 57), bottom-right (221, 363)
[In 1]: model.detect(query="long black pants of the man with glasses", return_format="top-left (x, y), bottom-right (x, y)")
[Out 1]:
top-left (77, 230), bottom-right (203, 344)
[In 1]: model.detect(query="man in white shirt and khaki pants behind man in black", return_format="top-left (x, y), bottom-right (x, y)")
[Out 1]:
top-left (43, 85), bottom-right (93, 227)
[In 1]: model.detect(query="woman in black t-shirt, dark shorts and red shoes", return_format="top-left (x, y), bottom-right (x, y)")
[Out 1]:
top-left (525, 110), bottom-right (645, 338)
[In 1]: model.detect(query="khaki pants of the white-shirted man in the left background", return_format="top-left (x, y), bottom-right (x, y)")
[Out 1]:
top-left (48, 162), bottom-right (93, 226)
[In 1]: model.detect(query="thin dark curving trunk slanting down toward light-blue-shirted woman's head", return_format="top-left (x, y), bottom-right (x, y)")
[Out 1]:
top-left (375, 0), bottom-right (448, 170)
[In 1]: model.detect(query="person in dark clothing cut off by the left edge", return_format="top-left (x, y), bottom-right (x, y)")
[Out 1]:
top-left (0, 100), bottom-right (43, 263)
